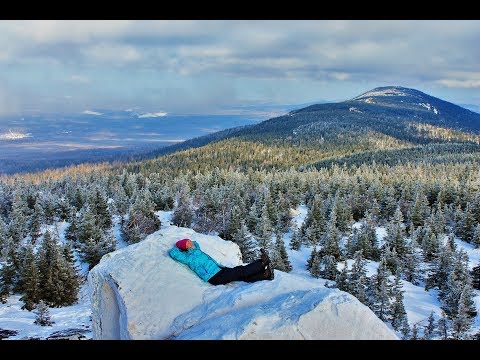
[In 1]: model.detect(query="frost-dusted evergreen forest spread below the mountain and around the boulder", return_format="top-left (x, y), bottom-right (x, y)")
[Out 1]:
top-left (0, 157), bottom-right (480, 339)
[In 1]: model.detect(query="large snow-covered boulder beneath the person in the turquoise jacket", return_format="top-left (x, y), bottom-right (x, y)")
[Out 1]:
top-left (88, 226), bottom-right (398, 340)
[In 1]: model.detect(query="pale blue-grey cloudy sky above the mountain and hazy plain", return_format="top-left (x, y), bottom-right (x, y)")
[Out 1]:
top-left (0, 20), bottom-right (480, 114)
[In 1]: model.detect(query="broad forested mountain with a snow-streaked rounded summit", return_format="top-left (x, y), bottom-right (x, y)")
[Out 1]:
top-left (143, 86), bottom-right (480, 172)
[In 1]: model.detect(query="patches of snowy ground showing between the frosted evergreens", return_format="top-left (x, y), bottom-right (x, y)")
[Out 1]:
top-left (0, 205), bottom-right (480, 340)
